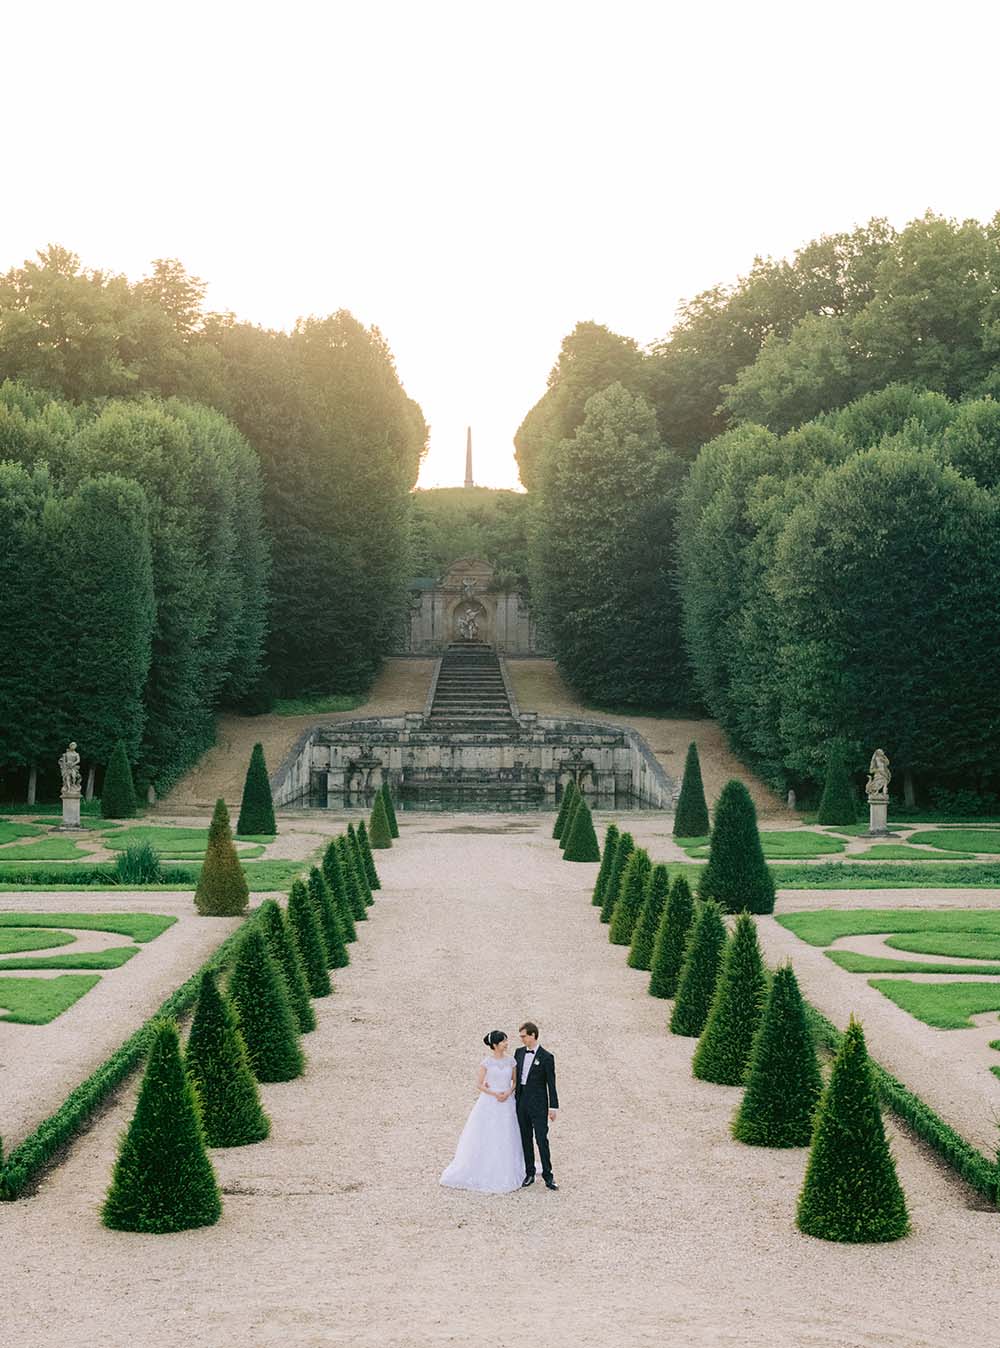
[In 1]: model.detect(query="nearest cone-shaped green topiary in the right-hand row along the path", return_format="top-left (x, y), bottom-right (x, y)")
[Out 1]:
top-left (795, 1016), bottom-right (910, 1243)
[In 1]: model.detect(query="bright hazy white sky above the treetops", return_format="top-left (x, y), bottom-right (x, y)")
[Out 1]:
top-left (0, 0), bottom-right (1000, 487)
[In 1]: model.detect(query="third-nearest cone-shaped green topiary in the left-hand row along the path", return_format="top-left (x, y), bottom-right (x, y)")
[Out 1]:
top-left (229, 923), bottom-right (303, 1081)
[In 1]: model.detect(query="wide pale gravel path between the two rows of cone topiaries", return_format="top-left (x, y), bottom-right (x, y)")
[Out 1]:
top-left (0, 814), bottom-right (1000, 1348)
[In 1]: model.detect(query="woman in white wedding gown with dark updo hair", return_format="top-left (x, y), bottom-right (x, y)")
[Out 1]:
top-left (441, 1030), bottom-right (524, 1193)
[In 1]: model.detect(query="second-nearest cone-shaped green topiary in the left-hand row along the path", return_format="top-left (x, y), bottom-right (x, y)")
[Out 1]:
top-left (185, 971), bottom-right (271, 1147)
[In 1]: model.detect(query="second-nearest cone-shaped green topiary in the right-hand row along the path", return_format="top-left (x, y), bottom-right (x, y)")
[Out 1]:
top-left (733, 964), bottom-right (822, 1147)
